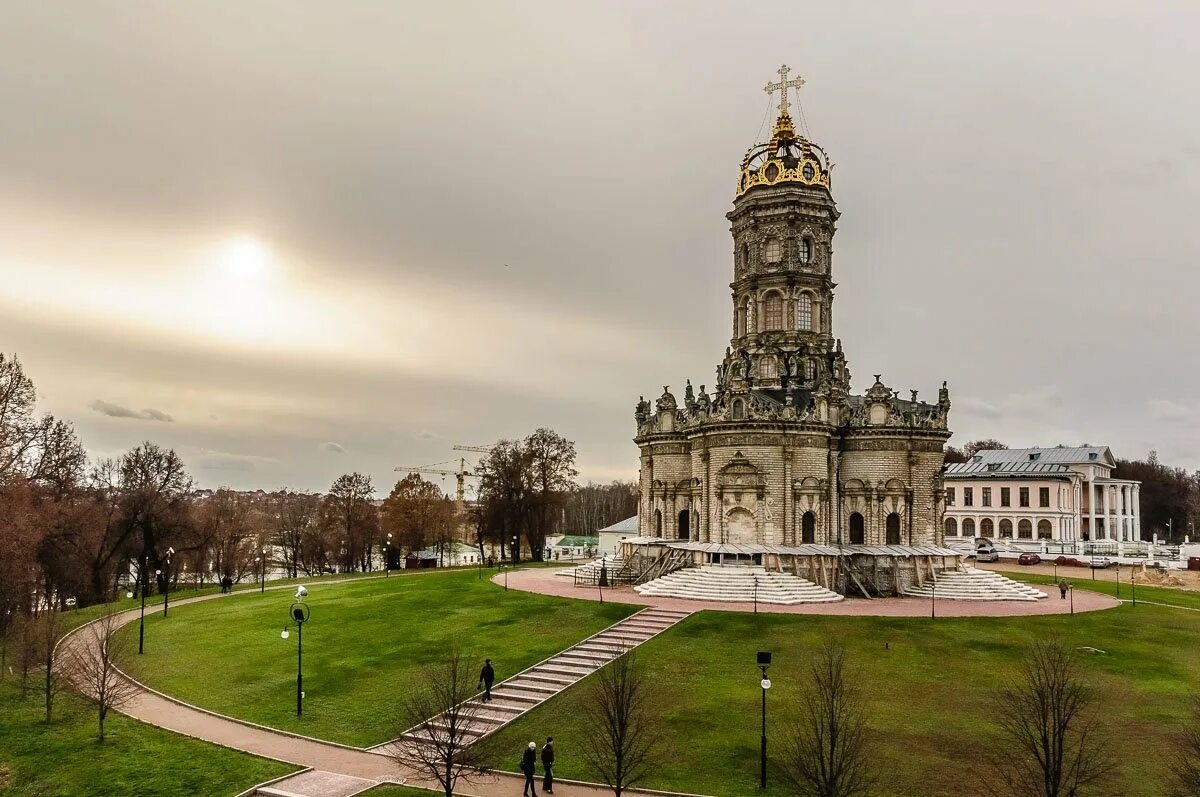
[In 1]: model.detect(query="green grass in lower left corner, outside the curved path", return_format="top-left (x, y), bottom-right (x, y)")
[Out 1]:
top-left (0, 676), bottom-right (296, 797)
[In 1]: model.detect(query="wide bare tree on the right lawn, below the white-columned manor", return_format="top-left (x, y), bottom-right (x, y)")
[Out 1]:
top-left (995, 640), bottom-right (1111, 797)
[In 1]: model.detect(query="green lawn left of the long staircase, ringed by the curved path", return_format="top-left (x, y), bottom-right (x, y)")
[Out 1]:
top-left (114, 569), bottom-right (636, 747)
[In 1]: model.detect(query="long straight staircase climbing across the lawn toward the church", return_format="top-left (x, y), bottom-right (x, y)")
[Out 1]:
top-left (372, 607), bottom-right (690, 751)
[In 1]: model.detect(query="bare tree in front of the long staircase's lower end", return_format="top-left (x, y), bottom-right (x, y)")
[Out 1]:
top-left (395, 649), bottom-right (487, 797)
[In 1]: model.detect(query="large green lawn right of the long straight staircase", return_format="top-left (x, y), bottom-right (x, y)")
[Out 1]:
top-left (484, 580), bottom-right (1200, 797)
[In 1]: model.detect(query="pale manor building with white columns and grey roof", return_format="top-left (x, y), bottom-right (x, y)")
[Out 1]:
top-left (943, 445), bottom-right (1141, 543)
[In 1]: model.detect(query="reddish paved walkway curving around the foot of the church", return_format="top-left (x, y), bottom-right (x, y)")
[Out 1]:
top-left (501, 570), bottom-right (1121, 617)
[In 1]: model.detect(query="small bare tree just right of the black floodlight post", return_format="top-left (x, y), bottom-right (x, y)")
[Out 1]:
top-left (779, 640), bottom-right (872, 797)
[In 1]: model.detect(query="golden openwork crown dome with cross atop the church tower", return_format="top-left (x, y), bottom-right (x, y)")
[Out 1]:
top-left (736, 65), bottom-right (833, 197)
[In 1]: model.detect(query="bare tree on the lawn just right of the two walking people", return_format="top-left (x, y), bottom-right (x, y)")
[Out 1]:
top-left (581, 651), bottom-right (659, 797)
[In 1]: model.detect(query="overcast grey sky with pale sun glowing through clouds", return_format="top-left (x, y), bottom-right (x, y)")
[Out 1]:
top-left (0, 0), bottom-right (1200, 491)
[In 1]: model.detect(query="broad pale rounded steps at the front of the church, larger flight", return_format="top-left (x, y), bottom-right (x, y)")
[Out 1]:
top-left (635, 565), bottom-right (842, 606)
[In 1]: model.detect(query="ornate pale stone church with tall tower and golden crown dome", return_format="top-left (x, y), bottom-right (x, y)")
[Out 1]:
top-left (634, 66), bottom-right (950, 551)
